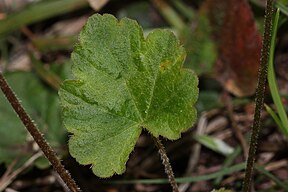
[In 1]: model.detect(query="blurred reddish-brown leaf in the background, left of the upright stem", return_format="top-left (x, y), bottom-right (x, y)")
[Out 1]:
top-left (203, 0), bottom-right (262, 96)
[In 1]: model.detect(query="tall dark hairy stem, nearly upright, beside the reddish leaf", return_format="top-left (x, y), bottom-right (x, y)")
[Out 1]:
top-left (243, 0), bottom-right (274, 192)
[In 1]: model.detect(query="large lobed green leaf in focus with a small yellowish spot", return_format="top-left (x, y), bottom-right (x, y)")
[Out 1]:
top-left (59, 14), bottom-right (198, 177)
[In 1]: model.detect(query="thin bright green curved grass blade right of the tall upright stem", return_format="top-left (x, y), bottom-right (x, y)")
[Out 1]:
top-left (268, 9), bottom-right (288, 137)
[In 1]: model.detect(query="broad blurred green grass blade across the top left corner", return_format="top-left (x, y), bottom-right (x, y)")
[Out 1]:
top-left (0, 0), bottom-right (88, 36)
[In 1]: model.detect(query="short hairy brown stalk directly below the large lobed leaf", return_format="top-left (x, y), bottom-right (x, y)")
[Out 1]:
top-left (152, 136), bottom-right (179, 192)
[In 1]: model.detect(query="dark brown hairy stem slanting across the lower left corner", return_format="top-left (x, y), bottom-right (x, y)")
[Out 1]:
top-left (0, 72), bottom-right (81, 192)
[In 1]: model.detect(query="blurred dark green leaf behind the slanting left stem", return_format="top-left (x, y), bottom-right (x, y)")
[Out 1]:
top-left (0, 72), bottom-right (66, 167)
